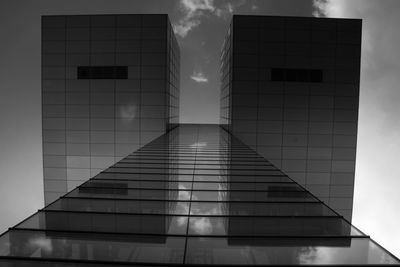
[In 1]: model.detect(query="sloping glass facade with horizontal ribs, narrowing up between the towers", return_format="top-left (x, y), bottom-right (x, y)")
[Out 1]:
top-left (0, 125), bottom-right (400, 266)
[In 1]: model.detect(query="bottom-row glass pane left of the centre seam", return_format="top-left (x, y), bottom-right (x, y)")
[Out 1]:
top-left (0, 230), bottom-right (185, 263)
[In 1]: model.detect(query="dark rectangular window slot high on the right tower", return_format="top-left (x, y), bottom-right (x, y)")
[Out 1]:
top-left (271, 68), bottom-right (323, 83)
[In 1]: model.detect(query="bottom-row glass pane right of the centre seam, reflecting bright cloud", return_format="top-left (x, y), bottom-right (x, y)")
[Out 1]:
top-left (185, 238), bottom-right (398, 265)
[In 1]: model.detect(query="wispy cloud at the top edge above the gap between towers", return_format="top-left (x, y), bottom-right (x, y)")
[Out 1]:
top-left (173, 0), bottom-right (246, 38)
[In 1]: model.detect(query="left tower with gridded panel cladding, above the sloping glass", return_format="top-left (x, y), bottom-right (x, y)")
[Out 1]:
top-left (42, 15), bottom-right (180, 204)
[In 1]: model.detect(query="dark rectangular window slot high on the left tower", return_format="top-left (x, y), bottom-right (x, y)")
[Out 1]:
top-left (78, 66), bottom-right (128, 79)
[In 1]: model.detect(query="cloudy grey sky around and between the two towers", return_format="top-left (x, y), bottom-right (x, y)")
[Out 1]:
top-left (0, 0), bottom-right (400, 257)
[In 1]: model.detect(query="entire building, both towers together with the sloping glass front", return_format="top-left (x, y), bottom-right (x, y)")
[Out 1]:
top-left (0, 15), bottom-right (400, 267)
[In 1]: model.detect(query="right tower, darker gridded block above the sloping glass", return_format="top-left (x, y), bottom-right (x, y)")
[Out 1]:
top-left (221, 15), bottom-right (361, 220)
